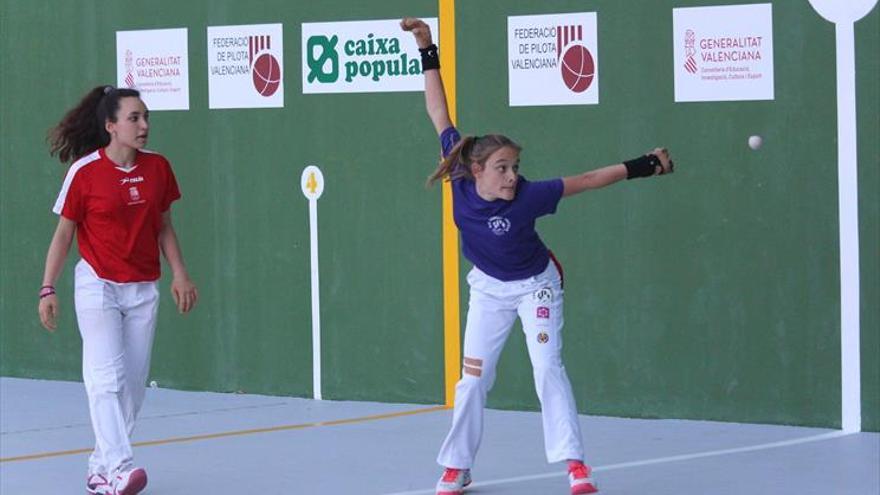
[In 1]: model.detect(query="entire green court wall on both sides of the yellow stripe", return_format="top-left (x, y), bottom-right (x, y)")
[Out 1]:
top-left (0, 0), bottom-right (880, 431)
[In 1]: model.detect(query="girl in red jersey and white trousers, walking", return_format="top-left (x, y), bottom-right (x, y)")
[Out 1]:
top-left (39, 86), bottom-right (198, 495)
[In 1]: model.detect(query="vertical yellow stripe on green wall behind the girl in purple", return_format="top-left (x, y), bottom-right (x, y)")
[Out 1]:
top-left (438, 0), bottom-right (461, 407)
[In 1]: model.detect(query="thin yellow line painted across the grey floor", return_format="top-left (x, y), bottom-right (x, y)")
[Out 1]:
top-left (0, 406), bottom-right (447, 462)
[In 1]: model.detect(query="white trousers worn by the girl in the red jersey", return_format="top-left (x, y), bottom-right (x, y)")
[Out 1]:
top-left (74, 260), bottom-right (159, 475)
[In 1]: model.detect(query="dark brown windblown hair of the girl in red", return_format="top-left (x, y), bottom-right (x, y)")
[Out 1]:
top-left (47, 86), bottom-right (141, 163)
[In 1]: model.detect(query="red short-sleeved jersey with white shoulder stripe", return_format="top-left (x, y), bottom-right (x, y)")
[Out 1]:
top-left (52, 149), bottom-right (180, 283)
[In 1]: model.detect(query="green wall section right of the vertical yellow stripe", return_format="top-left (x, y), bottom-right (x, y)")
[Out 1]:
top-left (457, 0), bottom-right (880, 430)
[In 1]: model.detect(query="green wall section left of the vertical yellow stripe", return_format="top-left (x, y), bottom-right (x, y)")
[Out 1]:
top-left (0, 0), bottom-right (443, 403)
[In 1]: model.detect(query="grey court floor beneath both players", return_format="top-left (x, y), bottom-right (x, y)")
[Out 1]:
top-left (0, 378), bottom-right (880, 495)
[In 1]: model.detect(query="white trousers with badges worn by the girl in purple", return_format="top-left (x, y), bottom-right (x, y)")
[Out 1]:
top-left (437, 260), bottom-right (584, 469)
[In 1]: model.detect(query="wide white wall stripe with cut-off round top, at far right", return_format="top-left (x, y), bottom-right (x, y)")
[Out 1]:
top-left (810, 0), bottom-right (877, 432)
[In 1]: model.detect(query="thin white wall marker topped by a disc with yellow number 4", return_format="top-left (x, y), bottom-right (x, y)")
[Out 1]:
top-left (299, 165), bottom-right (324, 400)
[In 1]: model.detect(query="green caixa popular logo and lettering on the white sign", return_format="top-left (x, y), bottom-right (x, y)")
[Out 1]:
top-left (306, 33), bottom-right (422, 84)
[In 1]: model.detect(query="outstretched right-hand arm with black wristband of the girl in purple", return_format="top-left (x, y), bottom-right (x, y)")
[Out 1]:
top-left (562, 148), bottom-right (673, 197)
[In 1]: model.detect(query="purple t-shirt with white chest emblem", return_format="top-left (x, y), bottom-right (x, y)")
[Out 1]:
top-left (440, 127), bottom-right (562, 282)
